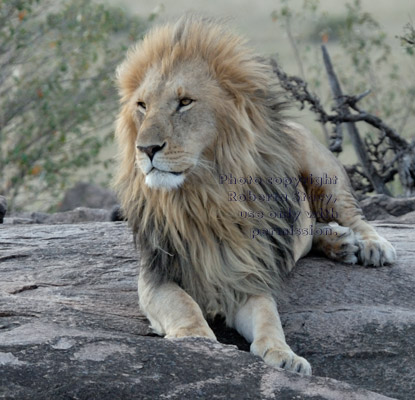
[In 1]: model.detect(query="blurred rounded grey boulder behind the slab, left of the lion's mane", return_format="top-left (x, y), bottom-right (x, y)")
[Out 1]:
top-left (59, 182), bottom-right (118, 211)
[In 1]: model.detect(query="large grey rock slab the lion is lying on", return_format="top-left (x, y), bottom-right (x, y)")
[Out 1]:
top-left (0, 222), bottom-right (415, 400)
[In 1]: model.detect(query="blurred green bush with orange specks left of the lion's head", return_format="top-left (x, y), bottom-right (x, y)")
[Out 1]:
top-left (0, 0), bottom-right (150, 210)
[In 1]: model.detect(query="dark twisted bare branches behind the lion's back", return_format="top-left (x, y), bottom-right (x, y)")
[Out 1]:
top-left (270, 49), bottom-right (415, 196)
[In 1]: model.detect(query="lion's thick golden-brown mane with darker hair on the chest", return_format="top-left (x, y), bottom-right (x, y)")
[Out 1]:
top-left (116, 15), bottom-right (299, 317)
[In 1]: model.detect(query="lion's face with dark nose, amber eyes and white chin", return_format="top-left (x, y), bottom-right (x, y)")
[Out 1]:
top-left (133, 63), bottom-right (220, 189)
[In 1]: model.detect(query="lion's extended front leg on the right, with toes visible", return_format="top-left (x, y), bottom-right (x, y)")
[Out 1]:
top-left (235, 296), bottom-right (311, 375)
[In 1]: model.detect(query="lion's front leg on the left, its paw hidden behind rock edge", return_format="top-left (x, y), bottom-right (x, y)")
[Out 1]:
top-left (138, 272), bottom-right (216, 340)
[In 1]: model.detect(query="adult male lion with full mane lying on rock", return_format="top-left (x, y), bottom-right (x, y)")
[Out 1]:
top-left (116, 16), bottom-right (395, 374)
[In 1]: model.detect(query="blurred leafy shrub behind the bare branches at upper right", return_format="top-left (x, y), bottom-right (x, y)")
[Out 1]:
top-left (271, 0), bottom-right (415, 195)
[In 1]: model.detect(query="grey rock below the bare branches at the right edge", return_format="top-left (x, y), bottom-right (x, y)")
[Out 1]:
top-left (360, 194), bottom-right (415, 221)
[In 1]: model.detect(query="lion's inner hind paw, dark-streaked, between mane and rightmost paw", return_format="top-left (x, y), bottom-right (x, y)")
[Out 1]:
top-left (313, 222), bottom-right (360, 264)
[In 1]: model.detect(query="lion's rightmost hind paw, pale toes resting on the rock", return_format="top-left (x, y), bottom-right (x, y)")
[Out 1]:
top-left (358, 236), bottom-right (396, 267)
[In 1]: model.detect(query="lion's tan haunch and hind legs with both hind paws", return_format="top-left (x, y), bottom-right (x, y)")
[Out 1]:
top-left (287, 123), bottom-right (396, 267)
